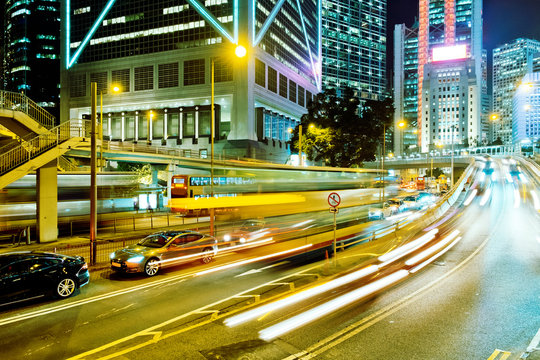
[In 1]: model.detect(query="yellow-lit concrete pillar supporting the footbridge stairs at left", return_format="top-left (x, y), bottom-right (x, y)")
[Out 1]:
top-left (36, 160), bottom-right (58, 243)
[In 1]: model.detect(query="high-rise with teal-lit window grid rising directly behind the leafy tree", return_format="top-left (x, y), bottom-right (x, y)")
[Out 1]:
top-left (322, 0), bottom-right (387, 100)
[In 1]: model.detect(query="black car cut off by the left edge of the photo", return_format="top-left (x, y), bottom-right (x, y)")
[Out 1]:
top-left (0, 251), bottom-right (90, 305)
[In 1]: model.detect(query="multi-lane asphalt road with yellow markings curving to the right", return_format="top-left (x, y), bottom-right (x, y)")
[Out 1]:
top-left (0, 158), bottom-right (540, 360)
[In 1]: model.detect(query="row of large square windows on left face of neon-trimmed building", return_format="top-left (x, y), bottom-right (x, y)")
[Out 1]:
top-left (70, 58), bottom-right (233, 97)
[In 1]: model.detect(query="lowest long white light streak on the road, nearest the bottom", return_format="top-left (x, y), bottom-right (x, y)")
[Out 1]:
top-left (259, 270), bottom-right (409, 341)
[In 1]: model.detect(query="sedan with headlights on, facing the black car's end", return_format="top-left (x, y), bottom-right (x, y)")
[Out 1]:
top-left (110, 230), bottom-right (218, 276)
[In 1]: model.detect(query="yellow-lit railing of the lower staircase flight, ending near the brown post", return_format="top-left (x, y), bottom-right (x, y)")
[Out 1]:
top-left (0, 120), bottom-right (91, 175)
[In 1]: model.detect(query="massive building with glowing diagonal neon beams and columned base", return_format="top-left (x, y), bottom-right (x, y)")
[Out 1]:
top-left (61, 0), bottom-right (321, 159)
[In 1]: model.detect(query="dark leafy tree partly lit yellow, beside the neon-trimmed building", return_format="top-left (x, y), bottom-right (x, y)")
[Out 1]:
top-left (290, 88), bottom-right (394, 167)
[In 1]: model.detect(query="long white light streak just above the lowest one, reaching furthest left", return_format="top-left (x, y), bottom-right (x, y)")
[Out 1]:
top-left (225, 265), bottom-right (379, 327)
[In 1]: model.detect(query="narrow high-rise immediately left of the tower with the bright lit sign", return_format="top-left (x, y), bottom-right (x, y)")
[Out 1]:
top-left (394, 23), bottom-right (418, 155)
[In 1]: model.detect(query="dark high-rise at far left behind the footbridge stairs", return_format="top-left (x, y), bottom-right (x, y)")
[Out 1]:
top-left (2, 0), bottom-right (60, 116)
